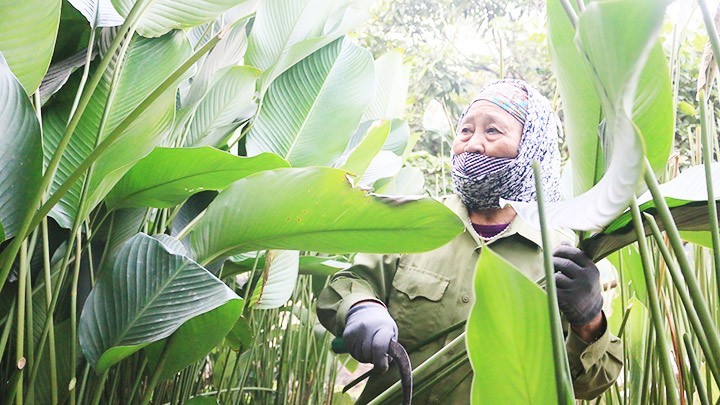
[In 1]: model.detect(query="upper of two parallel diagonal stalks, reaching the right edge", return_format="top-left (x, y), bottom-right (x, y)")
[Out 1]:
top-left (645, 159), bottom-right (720, 366)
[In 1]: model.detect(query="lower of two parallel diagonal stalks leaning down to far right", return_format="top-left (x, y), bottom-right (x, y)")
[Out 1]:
top-left (644, 214), bottom-right (720, 383)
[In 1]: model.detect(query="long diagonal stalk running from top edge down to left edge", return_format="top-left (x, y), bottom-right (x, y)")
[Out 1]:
top-left (0, 0), bottom-right (153, 292)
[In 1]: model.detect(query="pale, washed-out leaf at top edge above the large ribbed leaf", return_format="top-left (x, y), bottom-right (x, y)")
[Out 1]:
top-left (246, 0), bottom-right (369, 93)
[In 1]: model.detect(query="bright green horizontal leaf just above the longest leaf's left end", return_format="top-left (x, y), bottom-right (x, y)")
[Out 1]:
top-left (105, 146), bottom-right (289, 209)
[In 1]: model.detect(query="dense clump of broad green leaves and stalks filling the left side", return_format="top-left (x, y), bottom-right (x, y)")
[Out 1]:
top-left (0, 0), bottom-right (462, 404)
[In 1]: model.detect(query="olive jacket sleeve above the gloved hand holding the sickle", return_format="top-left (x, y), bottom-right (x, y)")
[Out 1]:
top-left (317, 254), bottom-right (399, 336)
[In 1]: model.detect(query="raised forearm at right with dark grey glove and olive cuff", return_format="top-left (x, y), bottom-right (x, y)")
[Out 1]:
top-left (553, 245), bottom-right (623, 399)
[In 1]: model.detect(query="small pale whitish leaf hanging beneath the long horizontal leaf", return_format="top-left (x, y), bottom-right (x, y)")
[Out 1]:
top-left (250, 250), bottom-right (300, 309)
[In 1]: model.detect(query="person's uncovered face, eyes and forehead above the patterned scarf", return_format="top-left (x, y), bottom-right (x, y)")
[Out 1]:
top-left (453, 100), bottom-right (523, 158)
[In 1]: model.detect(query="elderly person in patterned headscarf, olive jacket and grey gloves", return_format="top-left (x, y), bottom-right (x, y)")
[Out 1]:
top-left (317, 80), bottom-right (623, 404)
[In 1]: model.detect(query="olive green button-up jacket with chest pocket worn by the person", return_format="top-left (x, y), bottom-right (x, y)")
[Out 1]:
top-left (317, 196), bottom-right (623, 404)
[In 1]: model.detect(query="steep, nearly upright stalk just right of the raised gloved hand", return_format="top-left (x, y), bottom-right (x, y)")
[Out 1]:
top-left (631, 195), bottom-right (678, 404)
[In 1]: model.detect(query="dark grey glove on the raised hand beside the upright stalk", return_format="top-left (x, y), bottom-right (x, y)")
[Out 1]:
top-left (553, 245), bottom-right (603, 326)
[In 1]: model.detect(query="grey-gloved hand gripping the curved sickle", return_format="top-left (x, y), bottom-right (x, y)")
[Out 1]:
top-left (343, 301), bottom-right (398, 373)
